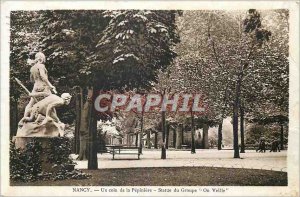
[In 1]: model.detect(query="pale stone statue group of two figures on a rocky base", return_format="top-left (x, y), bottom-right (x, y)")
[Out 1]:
top-left (16, 51), bottom-right (72, 137)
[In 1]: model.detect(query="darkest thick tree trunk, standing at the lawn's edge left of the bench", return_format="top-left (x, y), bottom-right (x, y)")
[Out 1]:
top-left (88, 89), bottom-right (98, 170)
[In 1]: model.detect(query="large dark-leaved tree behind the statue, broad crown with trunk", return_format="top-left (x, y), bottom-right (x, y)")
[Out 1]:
top-left (40, 10), bottom-right (179, 169)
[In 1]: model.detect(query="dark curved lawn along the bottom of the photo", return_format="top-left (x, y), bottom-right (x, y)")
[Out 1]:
top-left (11, 167), bottom-right (287, 186)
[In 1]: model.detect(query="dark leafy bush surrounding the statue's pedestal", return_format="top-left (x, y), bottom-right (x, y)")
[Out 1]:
top-left (10, 137), bottom-right (90, 182)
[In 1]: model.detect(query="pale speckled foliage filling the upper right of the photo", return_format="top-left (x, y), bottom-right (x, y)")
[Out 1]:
top-left (170, 9), bottom-right (288, 129)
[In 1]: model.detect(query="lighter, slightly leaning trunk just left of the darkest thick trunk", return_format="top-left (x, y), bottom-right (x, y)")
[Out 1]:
top-left (77, 89), bottom-right (93, 160)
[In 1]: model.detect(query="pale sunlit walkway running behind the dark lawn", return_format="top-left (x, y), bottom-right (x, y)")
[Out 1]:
top-left (72, 149), bottom-right (287, 172)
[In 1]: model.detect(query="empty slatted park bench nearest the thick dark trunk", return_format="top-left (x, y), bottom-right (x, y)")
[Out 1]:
top-left (106, 145), bottom-right (140, 160)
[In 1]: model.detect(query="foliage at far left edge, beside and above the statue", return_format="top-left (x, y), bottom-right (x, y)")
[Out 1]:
top-left (10, 11), bottom-right (39, 99)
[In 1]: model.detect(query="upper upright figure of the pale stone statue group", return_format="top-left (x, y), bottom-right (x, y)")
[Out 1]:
top-left (20, 52), bottom-right (57, 123)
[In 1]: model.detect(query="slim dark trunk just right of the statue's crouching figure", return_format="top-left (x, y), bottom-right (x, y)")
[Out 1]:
top-left (74, 87), bottom-right (82, 154)
